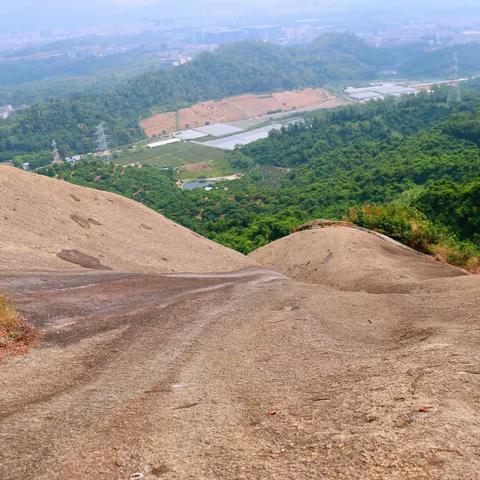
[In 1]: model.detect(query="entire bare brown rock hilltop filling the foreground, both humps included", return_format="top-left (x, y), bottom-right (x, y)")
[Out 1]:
top-left (0, 167), bottom-right (480, 480)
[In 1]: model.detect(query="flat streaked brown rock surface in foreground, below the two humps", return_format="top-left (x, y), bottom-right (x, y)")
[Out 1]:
top-left (0, 269), bottom-right (480, 480)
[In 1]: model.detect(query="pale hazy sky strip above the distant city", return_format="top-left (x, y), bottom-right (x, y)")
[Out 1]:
top-left (0, 0), bottom-right (480, 31)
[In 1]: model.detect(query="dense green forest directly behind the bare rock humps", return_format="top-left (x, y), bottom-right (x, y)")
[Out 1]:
top-left (44, 89), bottom-right (480, 269)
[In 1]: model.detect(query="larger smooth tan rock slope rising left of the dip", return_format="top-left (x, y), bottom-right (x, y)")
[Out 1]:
top-left (0, 166), bottom-right (253, 273)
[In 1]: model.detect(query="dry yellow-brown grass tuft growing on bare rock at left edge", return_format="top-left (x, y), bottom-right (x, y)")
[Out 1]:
top-left (0, 295), bottom-right (37, 360)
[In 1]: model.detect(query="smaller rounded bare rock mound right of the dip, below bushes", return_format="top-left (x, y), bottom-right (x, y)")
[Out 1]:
top-left (251, 226), bottom-right (465, 293)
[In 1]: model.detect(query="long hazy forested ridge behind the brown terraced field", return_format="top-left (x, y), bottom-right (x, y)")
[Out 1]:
top-left (0, 34), bottom-right (480, 165)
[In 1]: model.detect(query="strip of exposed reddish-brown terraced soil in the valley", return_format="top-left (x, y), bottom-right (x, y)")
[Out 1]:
top-left (141, 88), bottom-right (345, 138)
